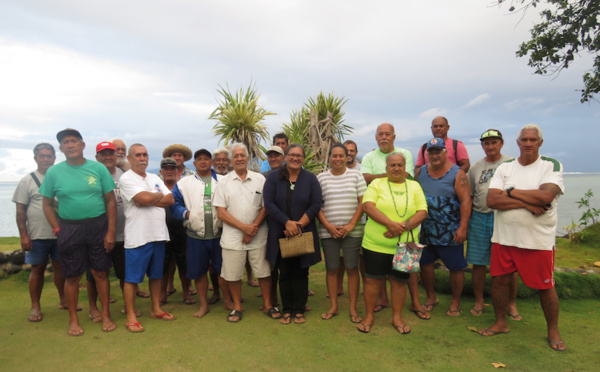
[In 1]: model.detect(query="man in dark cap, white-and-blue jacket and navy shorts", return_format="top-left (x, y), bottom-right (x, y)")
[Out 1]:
top-left (170, 149), bottom-right (233, 318)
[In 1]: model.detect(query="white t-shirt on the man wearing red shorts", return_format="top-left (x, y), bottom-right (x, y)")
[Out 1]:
top-left (489, 156), bottom-right (564, 251)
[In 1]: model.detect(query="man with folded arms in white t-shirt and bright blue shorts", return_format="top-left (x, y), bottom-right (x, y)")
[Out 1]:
top-left (119, 143), bottom-right (176, 333)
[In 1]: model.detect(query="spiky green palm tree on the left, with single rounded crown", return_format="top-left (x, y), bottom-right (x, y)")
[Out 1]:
top-left (208, 83), bottom-right (275, 169)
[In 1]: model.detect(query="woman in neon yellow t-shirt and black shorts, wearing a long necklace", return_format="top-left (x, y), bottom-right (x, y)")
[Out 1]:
top-left (358, 152), bottom-right (427, 334)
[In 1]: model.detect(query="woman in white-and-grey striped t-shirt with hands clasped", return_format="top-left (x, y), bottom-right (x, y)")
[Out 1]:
top-left (317, 143), bottom-right (367, 323)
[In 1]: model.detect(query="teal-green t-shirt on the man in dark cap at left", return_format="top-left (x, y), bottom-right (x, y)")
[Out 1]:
top-left (39, 160), bottom-right (115, 220)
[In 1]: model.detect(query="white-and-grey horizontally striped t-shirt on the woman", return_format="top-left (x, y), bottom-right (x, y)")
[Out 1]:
top-left (317, 169), bottom-right (367, 239)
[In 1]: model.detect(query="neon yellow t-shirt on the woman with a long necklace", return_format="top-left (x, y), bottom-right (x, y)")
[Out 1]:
top-left (362, 177), bottom-right (427, 254)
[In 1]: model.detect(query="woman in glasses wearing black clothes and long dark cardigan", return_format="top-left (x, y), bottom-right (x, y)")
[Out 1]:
top-left (263, 144), bottom-right (321, 324)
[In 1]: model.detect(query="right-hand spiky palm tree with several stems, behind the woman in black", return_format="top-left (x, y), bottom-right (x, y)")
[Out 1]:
top-left (283, 92), bottom-right (352, 173)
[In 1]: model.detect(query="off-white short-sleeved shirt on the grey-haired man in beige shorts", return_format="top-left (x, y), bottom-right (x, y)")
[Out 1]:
top-left (213, 171), bottom-right (267, 250)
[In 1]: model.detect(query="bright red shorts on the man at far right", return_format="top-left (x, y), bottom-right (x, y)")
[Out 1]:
top-left (490, 243), bottom-right (554, 289)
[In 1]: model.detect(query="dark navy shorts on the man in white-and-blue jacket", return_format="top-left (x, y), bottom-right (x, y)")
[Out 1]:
top-left (185, 237), bottom-right (223, 280)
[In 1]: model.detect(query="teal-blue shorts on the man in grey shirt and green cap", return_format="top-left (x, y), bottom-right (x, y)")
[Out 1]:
top-left (467, 211), bottom-right (494, 265)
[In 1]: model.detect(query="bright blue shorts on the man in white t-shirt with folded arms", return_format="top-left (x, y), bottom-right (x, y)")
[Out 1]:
top-left (125, 241), bottom-right (165, 284)
